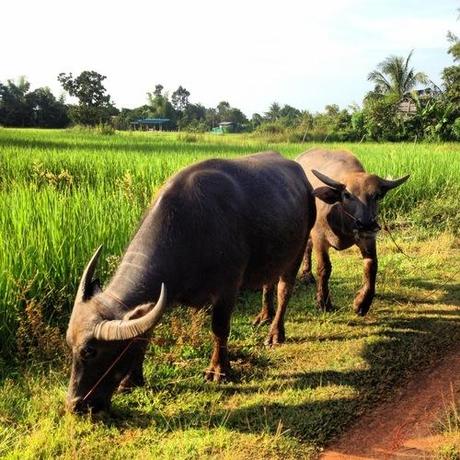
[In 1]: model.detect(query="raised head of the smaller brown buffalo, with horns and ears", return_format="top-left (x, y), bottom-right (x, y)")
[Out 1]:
top-left (312, 169), bottom-right (409, 237)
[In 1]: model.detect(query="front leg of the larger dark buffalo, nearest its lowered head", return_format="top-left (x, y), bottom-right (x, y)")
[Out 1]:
top-left (205, 298), bottom-right (235, 382)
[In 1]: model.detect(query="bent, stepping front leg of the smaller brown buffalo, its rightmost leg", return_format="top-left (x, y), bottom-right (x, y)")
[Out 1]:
top-left (353, 238), bottom-right (378, 316)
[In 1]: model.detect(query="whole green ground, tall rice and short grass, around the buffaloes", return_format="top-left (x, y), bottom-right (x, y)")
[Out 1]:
top-left (0, 129), bottom-right (460, 459)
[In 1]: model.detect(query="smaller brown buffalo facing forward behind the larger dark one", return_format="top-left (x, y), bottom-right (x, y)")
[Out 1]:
top-left (296, 150), bottom-right (409, 316)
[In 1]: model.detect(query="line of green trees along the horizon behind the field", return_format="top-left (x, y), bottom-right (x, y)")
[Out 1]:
top-left (0, 32), bottom-right (460, 141)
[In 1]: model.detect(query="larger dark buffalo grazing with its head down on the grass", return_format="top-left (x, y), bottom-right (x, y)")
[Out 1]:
top-left (67, 152), bottom-right (316, 412)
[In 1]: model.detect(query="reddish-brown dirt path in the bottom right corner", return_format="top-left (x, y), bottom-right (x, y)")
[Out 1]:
top-left (321, 346), bottom-right (460, 460)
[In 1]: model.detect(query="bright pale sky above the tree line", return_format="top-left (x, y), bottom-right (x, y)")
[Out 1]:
top-left (0, 0), bottom-right (460, 116)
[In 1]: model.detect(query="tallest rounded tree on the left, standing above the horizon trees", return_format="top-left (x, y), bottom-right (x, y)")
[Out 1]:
top-left (58, 70), bottom-right (118, 126)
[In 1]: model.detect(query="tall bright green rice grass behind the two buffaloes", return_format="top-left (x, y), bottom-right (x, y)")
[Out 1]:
top-left (0, 129), bottom-right (460, 353)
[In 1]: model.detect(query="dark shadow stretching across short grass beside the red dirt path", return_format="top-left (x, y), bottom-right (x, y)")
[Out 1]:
top-left (101, 310), bottom-right (460, 445)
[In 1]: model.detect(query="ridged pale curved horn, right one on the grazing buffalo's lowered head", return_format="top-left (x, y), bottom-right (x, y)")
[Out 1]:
top-left (94, 283), bottom-right (167, 341)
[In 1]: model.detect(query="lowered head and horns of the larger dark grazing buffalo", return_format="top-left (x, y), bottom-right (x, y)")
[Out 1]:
top-left (66, 246), bottom-right (166, 412)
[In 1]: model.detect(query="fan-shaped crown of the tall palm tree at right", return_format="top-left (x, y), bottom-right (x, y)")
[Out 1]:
top-left (367, 50), bottom-right (429, 98)
